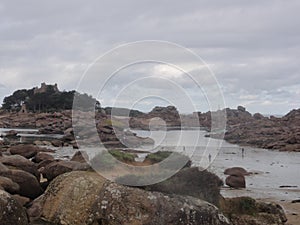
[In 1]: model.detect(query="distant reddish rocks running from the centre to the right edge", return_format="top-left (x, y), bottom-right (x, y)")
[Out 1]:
top-left (130, 106), bottom-right (300, 152)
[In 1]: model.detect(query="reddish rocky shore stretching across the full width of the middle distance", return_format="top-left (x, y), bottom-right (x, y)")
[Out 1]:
top-left (0, 106), bottom-right (300, 151)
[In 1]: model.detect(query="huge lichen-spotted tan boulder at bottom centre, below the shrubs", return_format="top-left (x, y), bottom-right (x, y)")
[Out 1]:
top-left (29, 171), bottom-right (229, 225)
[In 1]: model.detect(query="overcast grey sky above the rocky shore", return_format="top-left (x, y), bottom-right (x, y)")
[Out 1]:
top-left (0, 0), bottom-right (300, 114)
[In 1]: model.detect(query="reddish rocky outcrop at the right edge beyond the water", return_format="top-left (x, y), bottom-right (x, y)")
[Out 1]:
top-left (225, 109), bottom-right (300, 151)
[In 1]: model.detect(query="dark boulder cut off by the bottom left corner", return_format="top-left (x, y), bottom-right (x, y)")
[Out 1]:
top-left (0, 190), bottom-right (28, 225)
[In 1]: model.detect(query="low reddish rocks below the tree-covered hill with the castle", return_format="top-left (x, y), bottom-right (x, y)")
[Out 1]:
top-left (0, 110), bottom-right (153, 148)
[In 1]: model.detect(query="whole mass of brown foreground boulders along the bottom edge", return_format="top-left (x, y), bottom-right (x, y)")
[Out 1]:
top-left (0, 145), bottom-right (286, 225)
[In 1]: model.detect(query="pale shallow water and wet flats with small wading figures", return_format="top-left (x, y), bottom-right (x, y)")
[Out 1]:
top-left (135, 131), bottom-right (300, 200)
